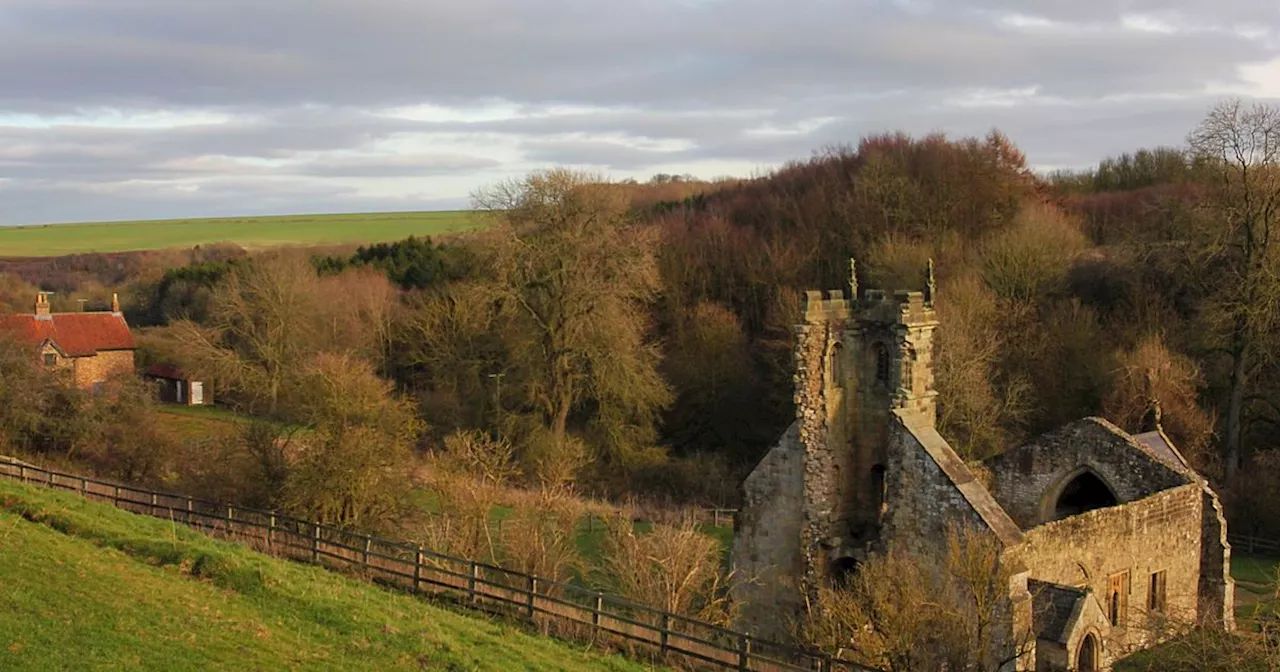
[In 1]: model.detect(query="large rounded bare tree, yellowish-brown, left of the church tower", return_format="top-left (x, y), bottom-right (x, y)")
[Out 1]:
top-left (474, 169), bottom-right (671, 478)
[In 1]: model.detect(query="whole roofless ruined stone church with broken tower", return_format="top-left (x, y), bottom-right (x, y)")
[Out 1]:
top-left (733, 262), bottom-right (1234, 671)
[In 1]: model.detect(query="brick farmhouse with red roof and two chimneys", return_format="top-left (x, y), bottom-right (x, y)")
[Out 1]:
top-left (0, 294), bottom-right (137, 390)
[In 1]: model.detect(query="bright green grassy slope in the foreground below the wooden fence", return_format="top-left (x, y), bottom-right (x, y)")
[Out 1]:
top-left (0, 481), bottom-right (644, 672)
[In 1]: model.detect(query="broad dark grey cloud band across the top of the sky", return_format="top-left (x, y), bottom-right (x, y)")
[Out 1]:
top-left (0, 0), bottom-right (1280, 109)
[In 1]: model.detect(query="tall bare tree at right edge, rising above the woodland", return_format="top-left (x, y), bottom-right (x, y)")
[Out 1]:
top-left (1188, 100), bottom-right (1280, 484)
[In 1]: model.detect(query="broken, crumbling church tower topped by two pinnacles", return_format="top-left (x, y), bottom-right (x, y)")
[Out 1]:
top-left (795, 261), bottom-right (938, 586)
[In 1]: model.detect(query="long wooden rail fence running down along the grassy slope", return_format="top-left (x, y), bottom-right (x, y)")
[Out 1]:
top-left (0, 458), bottom-right (870, 672)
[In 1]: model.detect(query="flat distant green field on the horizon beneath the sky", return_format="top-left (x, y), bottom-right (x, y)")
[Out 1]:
top-left (0, 210), bottom-right (479, 257)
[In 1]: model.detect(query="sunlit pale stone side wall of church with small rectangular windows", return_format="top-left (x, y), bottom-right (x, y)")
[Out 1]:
top-left (1011, 484), bottom-right (1203, 657)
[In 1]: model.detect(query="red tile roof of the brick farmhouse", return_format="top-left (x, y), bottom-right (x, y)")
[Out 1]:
top-left (0, 312), bottom-right (138, 357)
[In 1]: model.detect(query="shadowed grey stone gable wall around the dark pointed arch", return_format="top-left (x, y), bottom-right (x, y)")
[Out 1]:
top-left (983, 417), bottom-right (1190, 530)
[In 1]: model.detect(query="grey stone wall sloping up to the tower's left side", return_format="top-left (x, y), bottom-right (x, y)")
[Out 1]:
top-left (732, 424), bottom-right (804, 637)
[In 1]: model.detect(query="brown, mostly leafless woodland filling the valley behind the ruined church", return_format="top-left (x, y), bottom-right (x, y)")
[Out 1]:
top-left (0, 96), bottom-right (1280, 669)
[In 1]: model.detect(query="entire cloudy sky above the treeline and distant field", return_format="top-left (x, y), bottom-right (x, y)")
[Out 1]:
top-left (0, 0), bottom-right (1280, 224)
